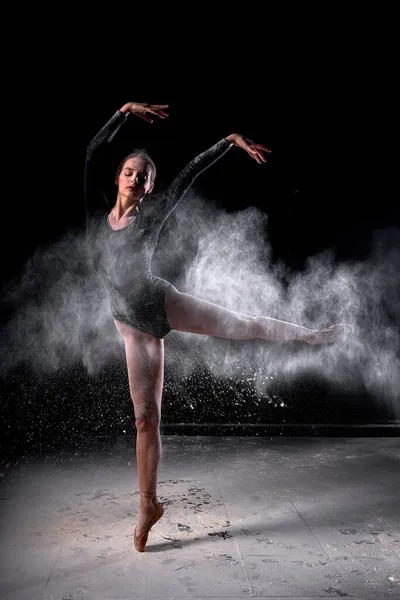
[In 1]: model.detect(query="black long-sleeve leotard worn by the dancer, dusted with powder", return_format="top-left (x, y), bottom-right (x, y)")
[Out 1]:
top-left (85, 111), bottom-right (231, 339)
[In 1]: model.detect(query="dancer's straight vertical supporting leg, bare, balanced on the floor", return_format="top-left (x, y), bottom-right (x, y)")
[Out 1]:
top-left (115, 321), bottom-right (164, 535)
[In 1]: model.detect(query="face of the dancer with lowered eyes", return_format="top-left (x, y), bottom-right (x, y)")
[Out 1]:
top-left (117, 156), bottom-right (154, 202)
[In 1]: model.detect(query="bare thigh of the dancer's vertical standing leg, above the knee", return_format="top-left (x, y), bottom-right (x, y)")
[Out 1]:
top-left (115, 319), bottom-right (164, 419)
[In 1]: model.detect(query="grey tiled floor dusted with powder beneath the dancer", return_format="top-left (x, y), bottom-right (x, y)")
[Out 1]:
top-left (0, 436), bottom-right (400, 600)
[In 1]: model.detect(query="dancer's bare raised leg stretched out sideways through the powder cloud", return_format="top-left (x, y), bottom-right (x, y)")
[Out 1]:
top-left (166, 286), bottom-right (341, 344)
